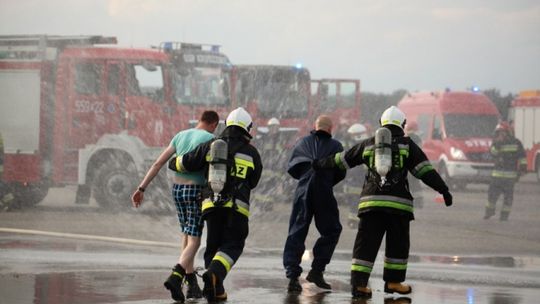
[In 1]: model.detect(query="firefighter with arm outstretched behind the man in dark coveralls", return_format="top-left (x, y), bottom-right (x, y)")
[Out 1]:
top-left (313, 106), bottom-right (452, 298)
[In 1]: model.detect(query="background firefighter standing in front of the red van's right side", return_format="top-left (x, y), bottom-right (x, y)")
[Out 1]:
top-left (484, 122), bottom-right (527, 221)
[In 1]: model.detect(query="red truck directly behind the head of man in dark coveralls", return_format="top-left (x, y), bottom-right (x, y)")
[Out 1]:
top-left (310, 79), bottom-right (361, 139)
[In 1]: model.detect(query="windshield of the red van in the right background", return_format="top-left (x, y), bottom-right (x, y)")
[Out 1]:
top-left (444, 114), bottom-right (499, 138)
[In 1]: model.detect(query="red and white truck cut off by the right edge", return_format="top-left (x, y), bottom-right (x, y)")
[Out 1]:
top-left (511, 90), bottom-right (540, 181)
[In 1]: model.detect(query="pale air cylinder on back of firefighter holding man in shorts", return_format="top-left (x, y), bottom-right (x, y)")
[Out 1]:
top-left (208, 139), bottom-right (228, 201)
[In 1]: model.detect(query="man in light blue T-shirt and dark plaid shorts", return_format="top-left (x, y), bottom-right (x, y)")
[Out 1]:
top-left (131, 111), bottom-right (219, 302)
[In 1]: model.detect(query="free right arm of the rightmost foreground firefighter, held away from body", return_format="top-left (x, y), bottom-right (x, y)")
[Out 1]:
top-left (407, 140), bottom-right (453, 207)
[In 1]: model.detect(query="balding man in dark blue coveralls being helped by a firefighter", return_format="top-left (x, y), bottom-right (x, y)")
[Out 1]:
top-left (283, 115), bottom-right (345, 292)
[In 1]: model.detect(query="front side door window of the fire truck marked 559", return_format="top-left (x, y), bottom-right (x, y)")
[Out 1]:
top-left (127, 64), bottom-right (163, 101)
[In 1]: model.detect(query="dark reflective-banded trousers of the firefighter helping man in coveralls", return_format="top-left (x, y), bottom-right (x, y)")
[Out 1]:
top-left (351, 211), bottom-right (410, 287)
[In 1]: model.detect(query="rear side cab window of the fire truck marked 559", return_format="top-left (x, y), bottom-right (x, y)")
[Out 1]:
top-left (75, 62), bottom-right (103, 95)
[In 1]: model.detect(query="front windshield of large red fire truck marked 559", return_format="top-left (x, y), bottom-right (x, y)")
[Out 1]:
top-left (173, 67), bottom-right (230, 105)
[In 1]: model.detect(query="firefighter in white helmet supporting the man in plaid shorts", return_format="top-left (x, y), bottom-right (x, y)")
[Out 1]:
top-left (169, 108), bottom-right (262, 302)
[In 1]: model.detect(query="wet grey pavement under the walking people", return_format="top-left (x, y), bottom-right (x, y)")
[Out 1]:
top-left (0, 173), bottom-right (540, 304)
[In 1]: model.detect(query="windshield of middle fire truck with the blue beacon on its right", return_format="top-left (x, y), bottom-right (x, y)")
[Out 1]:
top-left (240, 67), bottom-right (310, 118)
